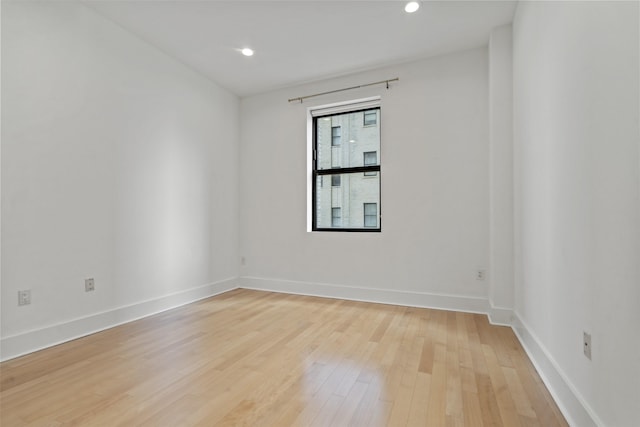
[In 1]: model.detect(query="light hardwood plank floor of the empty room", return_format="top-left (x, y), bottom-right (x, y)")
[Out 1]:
top-left (0, 289), bottom-right (567, 427)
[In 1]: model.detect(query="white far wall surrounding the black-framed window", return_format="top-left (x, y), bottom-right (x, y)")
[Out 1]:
top-left (241, 48), bottom-right (489, 311)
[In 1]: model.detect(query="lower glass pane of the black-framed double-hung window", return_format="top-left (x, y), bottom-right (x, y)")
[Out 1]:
top-left (315, 173), bottom-right (380, 229)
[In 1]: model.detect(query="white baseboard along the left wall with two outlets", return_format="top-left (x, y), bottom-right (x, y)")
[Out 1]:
top-left (0, 278), bottom-right (238, 361)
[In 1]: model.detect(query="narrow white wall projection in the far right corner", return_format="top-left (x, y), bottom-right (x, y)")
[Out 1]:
top-left (488, 25), bottom-right (514, 324)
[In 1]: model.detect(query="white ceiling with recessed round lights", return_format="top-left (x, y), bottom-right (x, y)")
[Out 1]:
top-left (85, 0), bottom-right (516, 96)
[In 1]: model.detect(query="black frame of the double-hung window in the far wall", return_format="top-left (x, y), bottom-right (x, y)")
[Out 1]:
top-left (311, 106), bottom-right (382, 233)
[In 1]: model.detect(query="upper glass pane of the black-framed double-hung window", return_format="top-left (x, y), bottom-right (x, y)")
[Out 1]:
top-left (314, 109), bottom-right (380, 170)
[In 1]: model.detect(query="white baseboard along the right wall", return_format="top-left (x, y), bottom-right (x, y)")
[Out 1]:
top-left (512, 312), bottom-right (604, 427)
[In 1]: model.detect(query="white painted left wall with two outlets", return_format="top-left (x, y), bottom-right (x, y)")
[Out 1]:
top-left (2, 2), bottom-right (239, 358)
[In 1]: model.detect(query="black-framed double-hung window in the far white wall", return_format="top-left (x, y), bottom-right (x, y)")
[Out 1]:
top-left (308, 98), bottom-right (381, 231)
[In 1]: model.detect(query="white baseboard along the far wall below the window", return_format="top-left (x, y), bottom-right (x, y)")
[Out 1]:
top-left (239, 277), bottom-right (489, 314)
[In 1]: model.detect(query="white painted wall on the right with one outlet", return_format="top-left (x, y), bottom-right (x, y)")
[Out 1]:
top-left (513, 2), bottom-right (640, 427)
